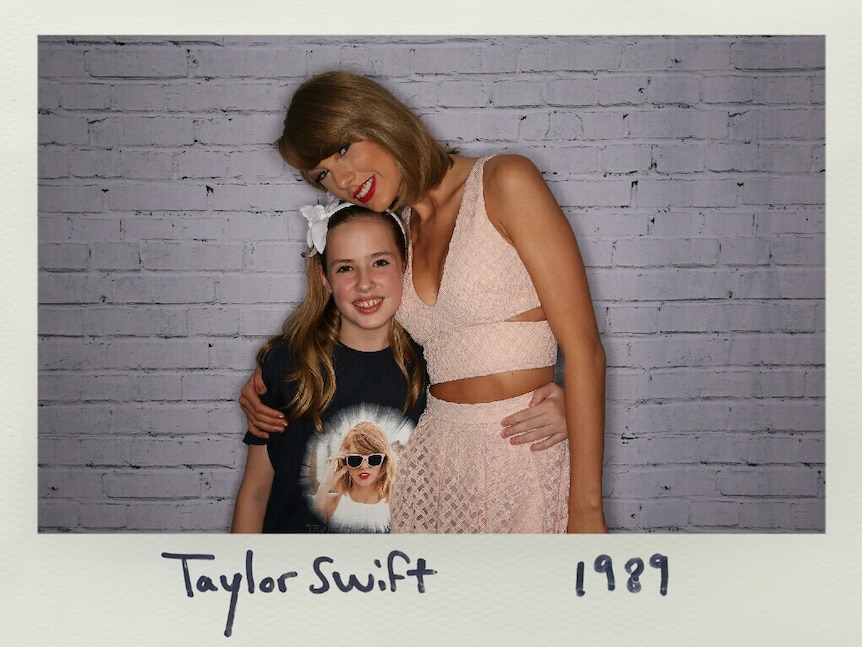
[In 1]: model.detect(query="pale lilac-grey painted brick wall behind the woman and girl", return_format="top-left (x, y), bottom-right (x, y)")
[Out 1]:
top-left (38, 37), bottom-right (825, 532)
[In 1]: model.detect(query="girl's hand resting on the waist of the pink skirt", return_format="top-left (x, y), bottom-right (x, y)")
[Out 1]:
top-left (500, 382), bottom-right (568, 451)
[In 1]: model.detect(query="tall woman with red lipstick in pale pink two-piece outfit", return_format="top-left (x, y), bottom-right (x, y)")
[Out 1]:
top-left (243, 72), bottom-right (607, 532)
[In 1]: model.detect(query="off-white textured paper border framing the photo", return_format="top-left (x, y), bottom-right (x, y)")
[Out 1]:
top-left (0, 2), bottom-right (860, 645)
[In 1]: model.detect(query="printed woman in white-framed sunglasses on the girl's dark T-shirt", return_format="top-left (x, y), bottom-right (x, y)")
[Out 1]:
top-left (314, 421), bottom-right (395, 532)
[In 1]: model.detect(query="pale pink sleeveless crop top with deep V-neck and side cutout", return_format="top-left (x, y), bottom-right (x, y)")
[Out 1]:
top-left (396, 157), bottom-right (557, 384)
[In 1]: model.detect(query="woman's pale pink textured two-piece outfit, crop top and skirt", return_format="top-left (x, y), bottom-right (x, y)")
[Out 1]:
top-left (391, 158), bottom-right (569, 533)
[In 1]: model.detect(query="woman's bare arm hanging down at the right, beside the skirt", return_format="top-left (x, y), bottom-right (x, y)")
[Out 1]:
top-left (484, 155), bottom-right (607, 532)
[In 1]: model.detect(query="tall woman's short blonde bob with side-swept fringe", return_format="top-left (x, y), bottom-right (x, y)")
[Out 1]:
top-left (276, 72), bottom-right (452, 209)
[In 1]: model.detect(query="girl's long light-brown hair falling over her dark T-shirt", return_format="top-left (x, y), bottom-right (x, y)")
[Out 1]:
top-left (257, 206), bottom-right (425, 433)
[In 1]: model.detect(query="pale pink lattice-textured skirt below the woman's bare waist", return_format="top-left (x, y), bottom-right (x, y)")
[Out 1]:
top-left (391, 393), bottom-right (569, 533)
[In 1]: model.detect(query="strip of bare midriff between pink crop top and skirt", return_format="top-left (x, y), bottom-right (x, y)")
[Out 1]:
top-left (431, 366), bottom-right (554, 404)
